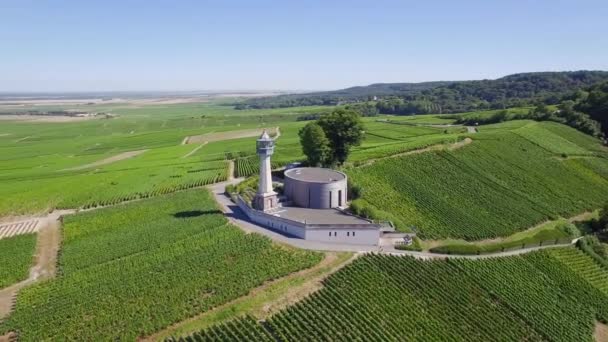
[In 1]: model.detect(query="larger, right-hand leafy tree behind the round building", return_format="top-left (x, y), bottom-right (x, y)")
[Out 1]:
top-left (318, 109), bottom-right (363, 165)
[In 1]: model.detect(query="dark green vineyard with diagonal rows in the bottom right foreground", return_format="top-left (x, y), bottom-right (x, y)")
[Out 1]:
top-left (178, 248), bottom-right (608, 341)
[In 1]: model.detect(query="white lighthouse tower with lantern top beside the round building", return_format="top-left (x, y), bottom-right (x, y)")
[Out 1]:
top-left (253, 130), bottom-right (278, 211)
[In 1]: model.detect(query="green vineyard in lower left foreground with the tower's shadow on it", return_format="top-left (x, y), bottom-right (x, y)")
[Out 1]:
top-left (0, 190), bottom-right (321, 341)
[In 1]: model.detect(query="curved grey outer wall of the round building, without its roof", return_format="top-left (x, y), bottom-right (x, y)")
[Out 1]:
top-left (284, 177), bottom-right (347, 209)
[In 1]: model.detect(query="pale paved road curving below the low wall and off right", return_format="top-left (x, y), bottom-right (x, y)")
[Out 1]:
top-left (208, 178), bottom-right (569, 259)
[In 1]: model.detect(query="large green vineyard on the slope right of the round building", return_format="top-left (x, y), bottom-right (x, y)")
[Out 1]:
top-left (347, 124), bottom-right (608, 240)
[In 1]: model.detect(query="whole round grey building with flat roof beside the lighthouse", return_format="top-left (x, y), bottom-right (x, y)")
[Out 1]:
top-left (283, 167), bottom-right (347, 209)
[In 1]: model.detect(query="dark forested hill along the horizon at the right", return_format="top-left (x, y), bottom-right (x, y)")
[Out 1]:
top-left (236, 71), bottom-right (608, 114)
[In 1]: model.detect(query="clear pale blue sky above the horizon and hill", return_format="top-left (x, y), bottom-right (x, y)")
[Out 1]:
top-left (0, 0), bottom-right (608, 91)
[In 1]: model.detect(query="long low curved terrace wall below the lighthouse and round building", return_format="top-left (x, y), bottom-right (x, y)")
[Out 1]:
top-left (236, 195), bottom-right (381, 246)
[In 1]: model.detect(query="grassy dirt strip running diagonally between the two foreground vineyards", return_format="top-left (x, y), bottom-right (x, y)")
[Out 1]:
top-left (139, 252), bottom-right (358, 341)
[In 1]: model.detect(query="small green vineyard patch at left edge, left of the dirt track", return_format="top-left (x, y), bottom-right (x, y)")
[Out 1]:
top-left (0, 234), bottom-right (36, 289)
